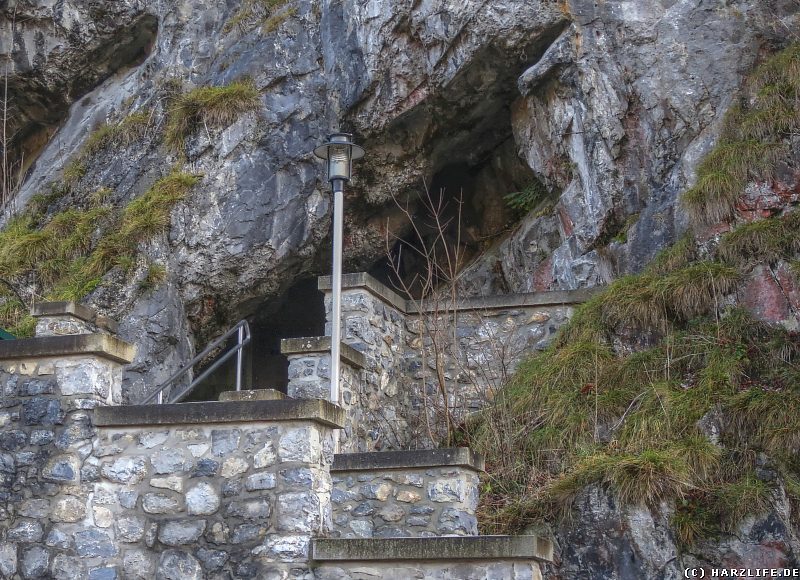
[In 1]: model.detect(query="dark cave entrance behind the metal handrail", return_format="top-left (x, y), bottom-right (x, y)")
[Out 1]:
top-left (186, 277), bottom-right (325, 402)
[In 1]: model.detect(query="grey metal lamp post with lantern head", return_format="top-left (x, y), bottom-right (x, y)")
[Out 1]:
top-left (314, 133), bottom-right (364, 405)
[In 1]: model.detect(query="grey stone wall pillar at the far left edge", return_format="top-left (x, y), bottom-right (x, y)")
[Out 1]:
top-left (0, 341), bottom-right (133, 579)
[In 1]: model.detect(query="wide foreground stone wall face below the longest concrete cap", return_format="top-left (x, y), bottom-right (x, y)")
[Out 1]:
top-left (85, 422), bottom-right (332, 580)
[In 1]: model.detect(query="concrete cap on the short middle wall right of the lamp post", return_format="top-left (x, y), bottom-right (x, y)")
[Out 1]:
top-left (331, 447), bottom-right (485, 471)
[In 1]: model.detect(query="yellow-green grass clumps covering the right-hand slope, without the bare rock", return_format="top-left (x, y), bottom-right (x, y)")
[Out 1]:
top-left (472, 46), bottom-right (800, 544)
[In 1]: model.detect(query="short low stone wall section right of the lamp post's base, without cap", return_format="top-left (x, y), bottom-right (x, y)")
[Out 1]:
top-left (331, 466), bottom-right (479, 540)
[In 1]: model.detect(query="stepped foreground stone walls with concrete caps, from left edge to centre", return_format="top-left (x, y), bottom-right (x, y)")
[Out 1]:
top-left (0, 302), bottom-right (549, 580)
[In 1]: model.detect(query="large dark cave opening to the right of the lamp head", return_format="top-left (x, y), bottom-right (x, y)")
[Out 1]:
top-left (357, 19), bottom-right (569, 297)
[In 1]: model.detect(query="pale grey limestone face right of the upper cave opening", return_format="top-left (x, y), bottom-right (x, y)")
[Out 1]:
top-left (465, 0), bottom-right (797, 294)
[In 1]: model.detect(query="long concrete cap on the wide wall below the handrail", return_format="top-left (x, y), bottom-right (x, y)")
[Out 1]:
top-left (94, 399), bottom-right (345, 429)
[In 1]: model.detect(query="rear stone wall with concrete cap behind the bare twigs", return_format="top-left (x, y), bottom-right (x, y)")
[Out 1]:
top-left (319, 273), bottom-right (592, 450)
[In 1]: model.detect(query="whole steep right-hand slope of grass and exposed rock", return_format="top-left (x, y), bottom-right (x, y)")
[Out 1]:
top-left (469, 44), bottom-right (800, 578)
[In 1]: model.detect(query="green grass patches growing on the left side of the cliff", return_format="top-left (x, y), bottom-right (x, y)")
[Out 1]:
top-left (0, 79), bottom-right (248, 337)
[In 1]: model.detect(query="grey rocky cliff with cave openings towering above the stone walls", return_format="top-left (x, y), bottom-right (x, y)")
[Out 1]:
top-left (0, 0), bottom-right (800, 577)
